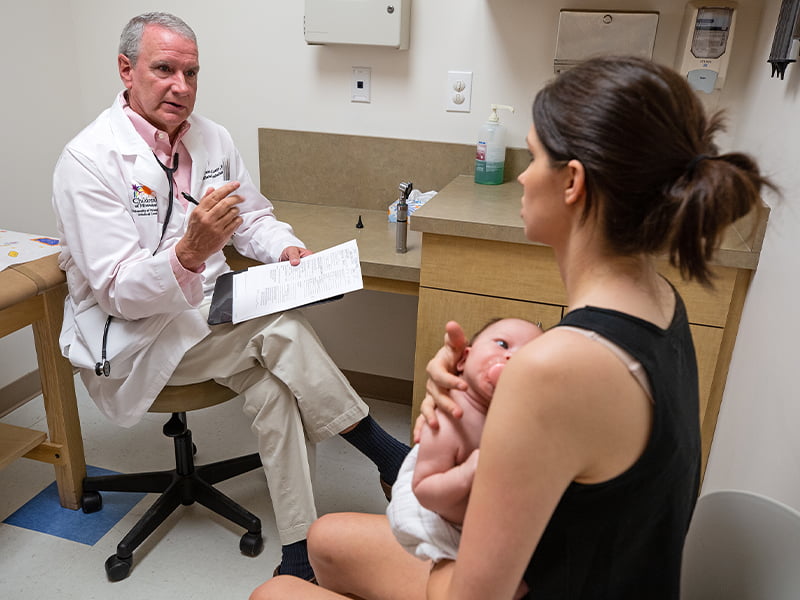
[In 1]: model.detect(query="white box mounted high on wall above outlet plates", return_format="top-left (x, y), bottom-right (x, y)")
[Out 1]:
top-left (304, 0), bottom-right (411, 50)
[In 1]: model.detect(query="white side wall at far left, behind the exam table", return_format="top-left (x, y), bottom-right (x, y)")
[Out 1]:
top-left (0, 0), bottom-right (81, 387)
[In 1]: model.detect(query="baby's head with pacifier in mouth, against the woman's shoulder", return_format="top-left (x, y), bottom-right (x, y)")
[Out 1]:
top-left (457, 319), bottom-right (543, 404)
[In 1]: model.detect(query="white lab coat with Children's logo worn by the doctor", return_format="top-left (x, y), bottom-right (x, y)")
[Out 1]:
top-left (53, 96), bottom-right (303, 427)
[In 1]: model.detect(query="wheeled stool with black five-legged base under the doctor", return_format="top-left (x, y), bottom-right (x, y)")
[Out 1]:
top-left (81, 381), bottom-right (264, 581)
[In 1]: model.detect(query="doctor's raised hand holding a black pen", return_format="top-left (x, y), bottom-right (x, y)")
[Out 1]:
top-left (175, 181), bottom-right (243, 272)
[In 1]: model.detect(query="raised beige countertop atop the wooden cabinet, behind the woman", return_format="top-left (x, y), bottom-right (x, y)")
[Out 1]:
top-left (409, 175), bottom-right (769, 269)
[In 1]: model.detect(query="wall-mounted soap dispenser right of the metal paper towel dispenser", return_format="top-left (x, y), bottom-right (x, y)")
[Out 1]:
top-left (675, 0), bottom-right (736, 94)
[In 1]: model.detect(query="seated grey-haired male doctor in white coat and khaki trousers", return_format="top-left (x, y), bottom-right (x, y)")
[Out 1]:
top-left (53, 13), bottom-right (408, 579)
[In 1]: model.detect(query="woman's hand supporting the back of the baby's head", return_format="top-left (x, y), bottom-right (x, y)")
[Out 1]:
top-left (414, 321), bottom-right (467, 442)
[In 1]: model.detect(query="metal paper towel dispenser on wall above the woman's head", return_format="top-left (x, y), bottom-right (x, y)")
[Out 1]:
top-left (553, 10), bottom-right (658, 74)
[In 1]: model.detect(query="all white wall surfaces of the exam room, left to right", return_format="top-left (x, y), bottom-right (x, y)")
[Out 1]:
top-left (0, 0), bottom-right (800, 508)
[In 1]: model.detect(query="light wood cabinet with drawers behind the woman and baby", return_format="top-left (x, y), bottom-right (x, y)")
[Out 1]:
top-left (412, 232), bottom-right (751, 480)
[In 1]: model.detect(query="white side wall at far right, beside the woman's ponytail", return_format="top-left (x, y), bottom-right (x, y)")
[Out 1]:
top-left (704, 0), bottom-right (800, 509)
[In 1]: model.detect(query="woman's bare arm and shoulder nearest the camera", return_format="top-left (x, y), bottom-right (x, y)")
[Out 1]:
top-left (428, 330), bottom-right (651, 600)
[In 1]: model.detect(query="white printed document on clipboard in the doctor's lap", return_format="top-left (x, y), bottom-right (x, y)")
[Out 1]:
top-left (232, 240), bottom-right (364, 323)
